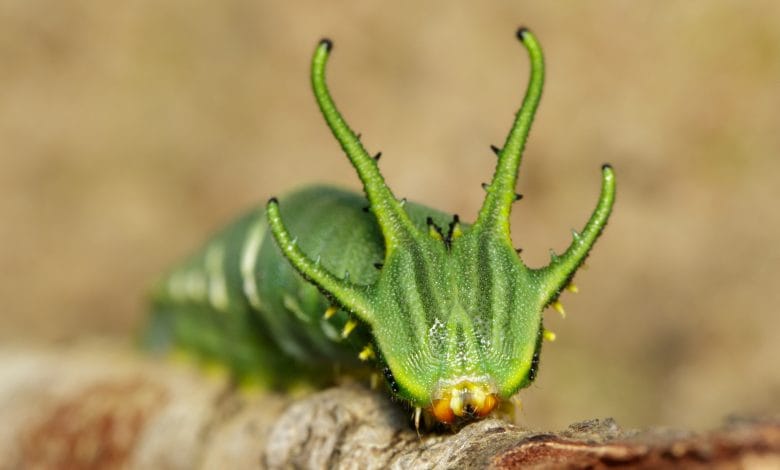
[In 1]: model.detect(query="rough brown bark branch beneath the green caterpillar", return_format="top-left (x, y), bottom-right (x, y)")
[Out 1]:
top-left (0, 346), bottom-right (780, 469)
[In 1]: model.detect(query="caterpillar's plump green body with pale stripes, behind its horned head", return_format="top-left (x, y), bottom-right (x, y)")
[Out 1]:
top-left (143, 186), bottom-right (452, 386)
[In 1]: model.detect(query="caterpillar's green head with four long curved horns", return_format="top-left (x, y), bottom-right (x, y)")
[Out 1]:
top-left (267, 28), bottom-right (615, 423)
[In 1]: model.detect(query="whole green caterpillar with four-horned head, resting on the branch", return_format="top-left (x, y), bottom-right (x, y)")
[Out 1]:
top-left (145, 28), bottom-right (615, 425)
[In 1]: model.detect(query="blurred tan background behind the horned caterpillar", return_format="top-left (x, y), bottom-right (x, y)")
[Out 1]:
top-left (0, 0), bottom-right (780, 429)
